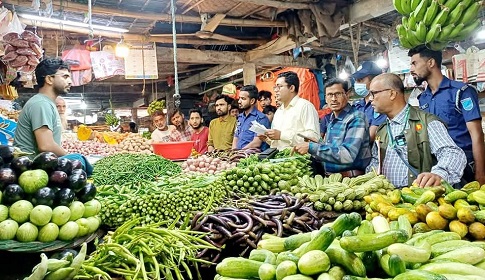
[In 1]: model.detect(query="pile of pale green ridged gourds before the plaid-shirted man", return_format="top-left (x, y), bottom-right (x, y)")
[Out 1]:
top-left (286, 172), bottom-right (394, 212)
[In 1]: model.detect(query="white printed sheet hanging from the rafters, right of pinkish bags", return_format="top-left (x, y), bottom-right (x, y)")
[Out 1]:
top-left (125, 43), bottom-right (158, 79)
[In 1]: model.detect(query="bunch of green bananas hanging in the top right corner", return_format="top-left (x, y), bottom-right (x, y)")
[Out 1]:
top-left (393, 0), bottom-right (482, 50)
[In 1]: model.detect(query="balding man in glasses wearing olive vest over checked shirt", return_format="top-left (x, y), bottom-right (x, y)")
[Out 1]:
top-left (368, 73), bottom-right (466, 187)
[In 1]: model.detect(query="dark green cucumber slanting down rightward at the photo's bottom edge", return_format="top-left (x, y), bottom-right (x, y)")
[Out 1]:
top-left (325, 240), bottom-right (366, 277)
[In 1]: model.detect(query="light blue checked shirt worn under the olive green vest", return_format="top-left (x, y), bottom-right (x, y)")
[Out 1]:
top-left (368, 105), bottom-right (466, 187)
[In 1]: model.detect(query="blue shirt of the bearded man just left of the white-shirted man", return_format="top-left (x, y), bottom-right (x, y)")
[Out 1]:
top-left (234, 107), bottom-right (271, 150)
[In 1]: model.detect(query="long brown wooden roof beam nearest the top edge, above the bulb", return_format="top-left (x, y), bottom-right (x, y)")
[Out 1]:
top-left (3, 0), bottom-right (286, 27)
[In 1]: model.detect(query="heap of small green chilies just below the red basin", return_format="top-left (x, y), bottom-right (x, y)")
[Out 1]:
top-left (92, 153), bottom-right (182, 185)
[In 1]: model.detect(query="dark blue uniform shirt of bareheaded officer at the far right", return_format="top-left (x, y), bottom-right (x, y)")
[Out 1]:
top-left (418, 77), bottom-right (482, 161)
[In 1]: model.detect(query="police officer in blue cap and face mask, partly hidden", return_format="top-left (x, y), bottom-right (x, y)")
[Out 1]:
top-left (352, 61), bottom-right (386, 142)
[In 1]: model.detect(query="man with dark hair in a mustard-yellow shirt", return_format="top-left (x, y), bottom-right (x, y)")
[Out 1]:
top-left (207, 94), bottom-right (237, 152)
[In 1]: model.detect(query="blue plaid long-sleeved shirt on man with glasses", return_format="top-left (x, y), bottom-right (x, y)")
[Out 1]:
top-left (309, 105), bottom-right (372, 173)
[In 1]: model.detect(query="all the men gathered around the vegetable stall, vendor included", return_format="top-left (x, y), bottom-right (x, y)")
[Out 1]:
top-left (14, 43), bottom-right (485, 187)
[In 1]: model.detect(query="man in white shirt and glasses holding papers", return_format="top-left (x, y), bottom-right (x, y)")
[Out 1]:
top-left (262, 71), bottom-right (320, 150)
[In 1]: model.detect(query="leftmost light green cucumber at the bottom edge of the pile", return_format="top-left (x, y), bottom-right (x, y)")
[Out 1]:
top-left (216, 257), bottom-right (262, 279)
